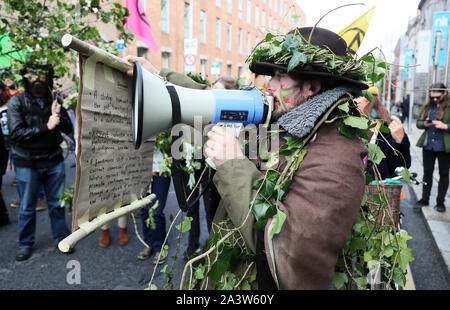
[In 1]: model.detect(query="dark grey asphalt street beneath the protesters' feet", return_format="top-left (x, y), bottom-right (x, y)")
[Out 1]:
top-left (0, 155), bottom-right (450, 290)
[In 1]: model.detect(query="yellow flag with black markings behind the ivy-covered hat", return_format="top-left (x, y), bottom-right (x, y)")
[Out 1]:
top-left (339, 6), bottom-right (375, 55)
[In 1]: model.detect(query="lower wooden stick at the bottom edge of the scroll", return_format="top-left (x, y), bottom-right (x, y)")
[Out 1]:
top-left (58, 194), bottom-right (156, 253)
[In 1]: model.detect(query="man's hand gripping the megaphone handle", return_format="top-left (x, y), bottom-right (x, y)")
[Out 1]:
top-left (205, 126), bottom-right (245, 167)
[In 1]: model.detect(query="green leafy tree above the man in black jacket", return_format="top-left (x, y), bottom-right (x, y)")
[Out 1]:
top-left (0, 0), bottom-right (134, 99)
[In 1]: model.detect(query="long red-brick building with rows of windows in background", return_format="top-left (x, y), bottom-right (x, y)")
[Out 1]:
top-left (112, 0), bottom-right (305, 81)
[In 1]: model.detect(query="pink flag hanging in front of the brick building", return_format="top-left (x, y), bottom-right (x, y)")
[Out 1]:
top-left (125, 0), bottom-right (158, 53)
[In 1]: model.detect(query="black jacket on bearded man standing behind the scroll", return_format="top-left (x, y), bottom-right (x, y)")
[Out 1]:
top-left (8, 91), bottom-right (73, 168)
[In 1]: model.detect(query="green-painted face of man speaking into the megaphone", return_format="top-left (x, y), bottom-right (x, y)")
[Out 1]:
top-left (267, 71), bottom-right (311, 119)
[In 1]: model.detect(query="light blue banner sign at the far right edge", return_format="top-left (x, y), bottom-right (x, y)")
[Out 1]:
top-left (431, 12), bottom-right (450, 67)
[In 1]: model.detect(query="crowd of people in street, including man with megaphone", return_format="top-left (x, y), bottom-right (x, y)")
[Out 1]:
top-left (0, 27), bottom-right (450, 289)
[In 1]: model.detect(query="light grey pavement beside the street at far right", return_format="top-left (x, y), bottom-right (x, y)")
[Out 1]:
top-left (405, 120), bottom-right (450, 273)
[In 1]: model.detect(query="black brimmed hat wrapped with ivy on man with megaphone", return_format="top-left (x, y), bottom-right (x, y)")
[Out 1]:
top-left (250, 27), bottom-right (368, 90)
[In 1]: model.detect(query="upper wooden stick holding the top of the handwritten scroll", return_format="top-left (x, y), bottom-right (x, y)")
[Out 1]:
top-left (61, 33), bottom-right (133, 72)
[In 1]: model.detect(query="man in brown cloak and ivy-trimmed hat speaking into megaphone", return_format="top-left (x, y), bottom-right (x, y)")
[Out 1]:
top-left (206, 27), bottom-right (368, 289)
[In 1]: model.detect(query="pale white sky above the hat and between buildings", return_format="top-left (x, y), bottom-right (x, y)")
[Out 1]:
top-left (296, 0), bottom-right (420, 61)
